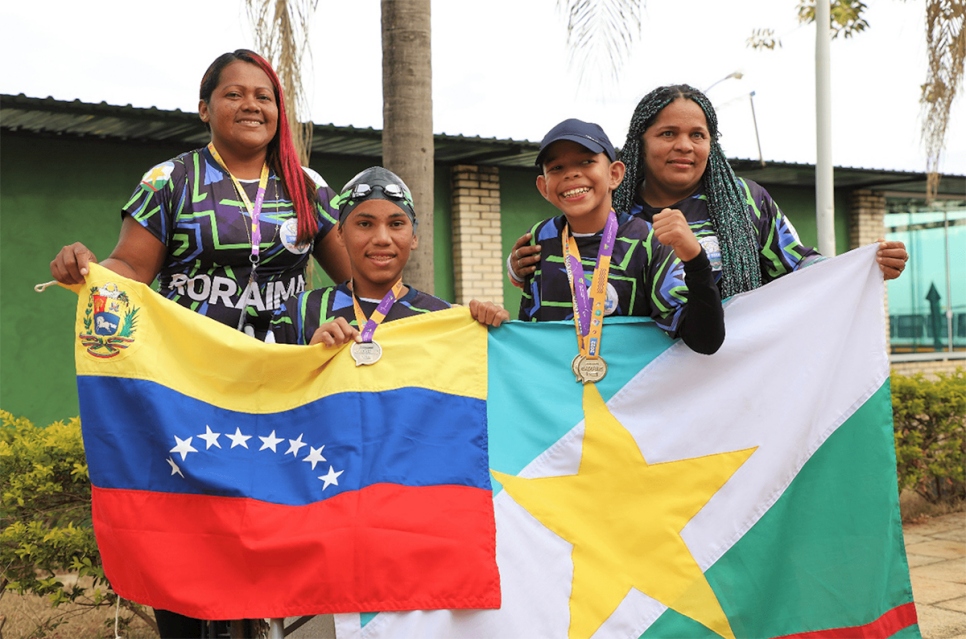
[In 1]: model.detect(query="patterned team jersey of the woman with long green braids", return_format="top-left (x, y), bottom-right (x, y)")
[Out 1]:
top-left (631, 178), bottom-right (821, 284)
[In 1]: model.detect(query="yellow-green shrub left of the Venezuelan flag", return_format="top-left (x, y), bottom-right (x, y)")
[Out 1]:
top-left (0, 410), bottom-right (154, 634)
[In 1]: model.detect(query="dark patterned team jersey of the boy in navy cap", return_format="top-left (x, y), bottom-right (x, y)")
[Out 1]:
top-left (519, 213), bottom-right (688, 337)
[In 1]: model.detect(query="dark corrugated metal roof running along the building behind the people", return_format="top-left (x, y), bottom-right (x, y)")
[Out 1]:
top-left (0, 94), bottom-right (966, 197)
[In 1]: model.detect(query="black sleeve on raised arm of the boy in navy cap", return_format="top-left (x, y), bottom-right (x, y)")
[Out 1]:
top-left (678, 249), bottom-right (724, 355)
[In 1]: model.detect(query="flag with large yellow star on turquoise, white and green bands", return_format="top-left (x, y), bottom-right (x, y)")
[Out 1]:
top-left (336, 246), bottom-right (919, 639)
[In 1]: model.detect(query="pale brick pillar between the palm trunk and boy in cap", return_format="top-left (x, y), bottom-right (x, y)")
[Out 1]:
top-left (452, 165), bottom-right (506, 306)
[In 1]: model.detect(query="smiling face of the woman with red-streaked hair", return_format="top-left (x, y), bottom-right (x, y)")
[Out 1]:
top-left (198, 60), bottom-right (278, 169)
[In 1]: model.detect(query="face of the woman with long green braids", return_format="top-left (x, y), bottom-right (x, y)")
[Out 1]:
top-left (641, 98), bottom-right (711, 208)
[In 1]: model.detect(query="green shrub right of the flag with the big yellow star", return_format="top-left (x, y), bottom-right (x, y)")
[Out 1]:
top-left (892, 368), bottom-right (966, 504)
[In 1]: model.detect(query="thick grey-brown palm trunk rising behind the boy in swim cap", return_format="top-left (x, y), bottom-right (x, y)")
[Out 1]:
top-left (382, 0), bottom-right (435, 293)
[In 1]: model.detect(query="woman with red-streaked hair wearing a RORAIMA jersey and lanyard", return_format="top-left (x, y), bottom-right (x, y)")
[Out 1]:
top-left (50, 49), bottom-right (349, 340)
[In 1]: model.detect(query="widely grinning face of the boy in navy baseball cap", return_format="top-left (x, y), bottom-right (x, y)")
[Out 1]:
top-left (537, 140), bottom-right (624, 233)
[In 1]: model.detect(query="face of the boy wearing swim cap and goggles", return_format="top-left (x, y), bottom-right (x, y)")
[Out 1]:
top-left (339, 199), bottom-right (418, 299)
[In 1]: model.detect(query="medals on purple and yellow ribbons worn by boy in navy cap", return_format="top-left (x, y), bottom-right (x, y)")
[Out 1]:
top-left (561, 211), bottom-right (617, 384)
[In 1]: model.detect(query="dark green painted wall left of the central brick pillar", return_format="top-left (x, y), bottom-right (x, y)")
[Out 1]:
top-left (0, 131), bottom-right (454, 425)
